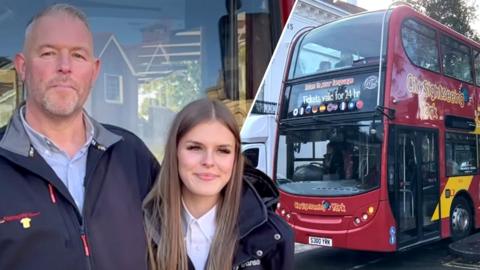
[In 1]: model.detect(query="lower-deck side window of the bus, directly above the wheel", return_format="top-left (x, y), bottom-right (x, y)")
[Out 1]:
top-left (445, 132), bottom-right (477, 176)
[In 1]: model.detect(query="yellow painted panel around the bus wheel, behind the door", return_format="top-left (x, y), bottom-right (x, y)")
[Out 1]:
top-left (431, 175), bottom-right (473, 221)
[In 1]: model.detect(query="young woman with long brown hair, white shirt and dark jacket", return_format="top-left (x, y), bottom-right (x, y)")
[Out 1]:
top-left (144, 99), bottom-right (294, 270)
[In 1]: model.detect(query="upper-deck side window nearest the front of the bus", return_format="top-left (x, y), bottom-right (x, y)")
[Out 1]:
top-left (401, 19), bottom-right (440, 71)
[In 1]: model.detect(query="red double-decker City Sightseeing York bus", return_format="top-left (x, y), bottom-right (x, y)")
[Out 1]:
top-left (274, 6), bottom-right (480, 251)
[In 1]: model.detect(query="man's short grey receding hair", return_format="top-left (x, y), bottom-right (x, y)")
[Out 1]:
top-left (25, 4), bottom-right (91, 40)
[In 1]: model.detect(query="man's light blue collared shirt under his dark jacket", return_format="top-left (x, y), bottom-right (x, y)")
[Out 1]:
top-left (20, 106), bottom-right (94, 213)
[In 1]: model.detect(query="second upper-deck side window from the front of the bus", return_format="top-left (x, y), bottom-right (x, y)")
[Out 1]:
top-left (441, 36), bottom-right (473, 83)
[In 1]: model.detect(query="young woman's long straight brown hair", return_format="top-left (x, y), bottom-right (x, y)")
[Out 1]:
top-left (144, 99), bottom-right (243, 270)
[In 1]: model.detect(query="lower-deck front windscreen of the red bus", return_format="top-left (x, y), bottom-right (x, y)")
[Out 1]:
top-left (276, 121), bottom-right (381, 196)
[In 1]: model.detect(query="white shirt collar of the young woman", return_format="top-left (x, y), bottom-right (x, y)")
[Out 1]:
top-left (182, 198), bottom-right (217, 241)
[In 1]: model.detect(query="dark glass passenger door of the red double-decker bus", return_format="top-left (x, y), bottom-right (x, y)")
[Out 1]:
top-left (388, 126), bottom-right (440, 249)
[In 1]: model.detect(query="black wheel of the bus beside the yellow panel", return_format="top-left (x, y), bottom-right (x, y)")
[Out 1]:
top-left (450, 196), bottom-right (473, 241)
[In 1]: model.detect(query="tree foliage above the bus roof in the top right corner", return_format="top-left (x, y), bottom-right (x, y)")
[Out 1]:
top-left (407, 0), bottom-right (480, 41)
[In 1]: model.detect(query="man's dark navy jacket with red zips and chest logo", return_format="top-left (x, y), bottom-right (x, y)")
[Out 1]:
top-left (0, 110), bottom-right (159, 270)
